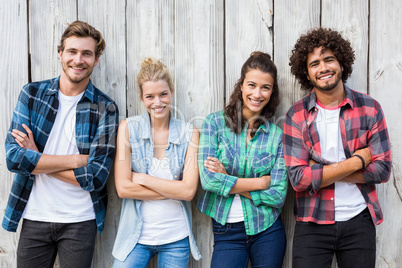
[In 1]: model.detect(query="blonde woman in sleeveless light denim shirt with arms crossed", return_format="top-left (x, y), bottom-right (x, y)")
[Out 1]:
top-left (113, 58), bottom-right (201, 268)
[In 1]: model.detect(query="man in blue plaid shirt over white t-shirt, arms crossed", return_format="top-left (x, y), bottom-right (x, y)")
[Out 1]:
top-left (2, 21), bottom-right (118, 267)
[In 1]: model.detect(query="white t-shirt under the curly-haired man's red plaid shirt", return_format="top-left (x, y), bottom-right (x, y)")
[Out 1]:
top-left (316, 101), bottom-right (367, 221)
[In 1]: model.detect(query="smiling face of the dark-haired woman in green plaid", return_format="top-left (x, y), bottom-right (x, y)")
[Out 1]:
top-left (240, 69), bottom-right (274, 119)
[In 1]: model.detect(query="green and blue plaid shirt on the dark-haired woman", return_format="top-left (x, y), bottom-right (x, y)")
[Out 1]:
top-left (198, 111), bottom-right (288, 235)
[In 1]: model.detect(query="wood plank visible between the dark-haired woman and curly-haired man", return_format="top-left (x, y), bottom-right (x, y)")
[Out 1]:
top-left (274, 0), bottom-right (320, 267)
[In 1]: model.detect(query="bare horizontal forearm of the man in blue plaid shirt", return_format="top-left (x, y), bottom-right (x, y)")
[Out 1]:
top-left (32, 154), bottom-right (88, 175)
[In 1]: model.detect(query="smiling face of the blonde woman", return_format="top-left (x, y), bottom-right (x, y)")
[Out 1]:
top-left (141, 80), bottom-right (173, 119)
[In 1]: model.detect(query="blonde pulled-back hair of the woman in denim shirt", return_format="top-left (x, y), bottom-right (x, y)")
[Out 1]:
top-left (137, 58), bottom-right (174, 96)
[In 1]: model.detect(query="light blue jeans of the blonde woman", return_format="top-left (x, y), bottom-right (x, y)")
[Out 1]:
top-left (113, 237), bottom-right (190, 268)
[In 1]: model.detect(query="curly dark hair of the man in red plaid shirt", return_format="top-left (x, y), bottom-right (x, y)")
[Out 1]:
top-left (289, 27), bottom-right (355, 91)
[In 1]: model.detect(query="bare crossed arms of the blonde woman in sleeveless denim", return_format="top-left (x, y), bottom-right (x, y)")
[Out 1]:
top-left (114, 120), bottom-right (199, 201)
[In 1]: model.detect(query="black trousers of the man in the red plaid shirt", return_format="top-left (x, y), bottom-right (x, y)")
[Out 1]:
top-left (293, 209), bottom-right (376, 268)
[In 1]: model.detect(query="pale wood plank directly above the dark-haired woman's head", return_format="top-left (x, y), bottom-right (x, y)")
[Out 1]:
top-left (225, 0), bottom-right (273, 103)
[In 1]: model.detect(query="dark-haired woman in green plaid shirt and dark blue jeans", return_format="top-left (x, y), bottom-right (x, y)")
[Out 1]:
top-left (198, 52), bottom-right (288, 268)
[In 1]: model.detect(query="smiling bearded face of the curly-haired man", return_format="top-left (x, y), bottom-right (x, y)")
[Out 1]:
top-left (307, 47), bottom-right (343, 92)
